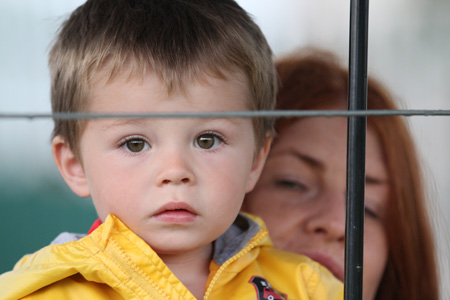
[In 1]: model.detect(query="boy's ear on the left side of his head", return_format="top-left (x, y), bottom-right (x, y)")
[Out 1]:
top-left (52, 136), bottom-right (90, 197)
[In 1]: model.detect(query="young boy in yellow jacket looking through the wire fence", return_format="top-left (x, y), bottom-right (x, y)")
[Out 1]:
top-left (0, 0), bottom-right (343, 300)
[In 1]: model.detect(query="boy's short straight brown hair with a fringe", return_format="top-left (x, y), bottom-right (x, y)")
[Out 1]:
top-left (49, 0), bottom-right (277, 154)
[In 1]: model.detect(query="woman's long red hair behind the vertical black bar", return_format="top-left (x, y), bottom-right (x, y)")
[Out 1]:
top-left (275, 48), bottom-right (439, 300)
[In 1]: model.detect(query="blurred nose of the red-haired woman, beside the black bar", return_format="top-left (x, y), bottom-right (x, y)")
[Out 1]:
top-left (306, 191), bottom-right (345, 242)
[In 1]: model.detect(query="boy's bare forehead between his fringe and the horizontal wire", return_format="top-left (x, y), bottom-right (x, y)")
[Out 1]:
top-left (88, 63), bottom-right (252, 113)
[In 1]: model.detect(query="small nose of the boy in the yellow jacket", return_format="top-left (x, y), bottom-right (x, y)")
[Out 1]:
top-left (156, 151), bottom-right (195, 186)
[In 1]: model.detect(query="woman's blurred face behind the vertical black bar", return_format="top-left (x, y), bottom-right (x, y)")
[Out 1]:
top-left (243, 110), bottom-right (388, 300)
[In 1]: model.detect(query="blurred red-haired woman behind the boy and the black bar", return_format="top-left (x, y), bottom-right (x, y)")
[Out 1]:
top-left (243, 50), bottom-right (438, 300)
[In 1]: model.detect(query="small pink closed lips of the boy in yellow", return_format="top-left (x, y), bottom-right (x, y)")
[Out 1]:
top-left (153, 202), bottom-right (198, 224)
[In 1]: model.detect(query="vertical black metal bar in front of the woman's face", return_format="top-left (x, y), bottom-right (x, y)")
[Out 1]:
top-left (344, 0), bottom-right (369, 300)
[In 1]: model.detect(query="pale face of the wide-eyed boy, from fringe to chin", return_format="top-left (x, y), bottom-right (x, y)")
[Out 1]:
top-left (62, 73), bottom-right (265, 254)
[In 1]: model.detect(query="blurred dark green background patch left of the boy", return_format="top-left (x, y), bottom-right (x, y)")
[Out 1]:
top-left (0, 172), bottom-right (96, 273)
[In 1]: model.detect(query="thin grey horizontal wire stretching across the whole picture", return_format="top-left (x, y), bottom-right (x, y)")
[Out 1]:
top-left (0, 110), bottom-right (450, 120)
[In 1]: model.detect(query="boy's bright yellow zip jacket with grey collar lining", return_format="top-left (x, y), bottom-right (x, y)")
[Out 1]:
top-left (0, 215), bottom-right (343, 300)
